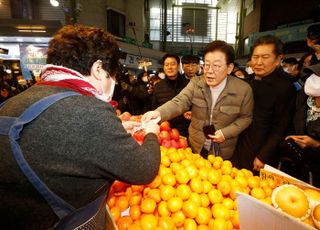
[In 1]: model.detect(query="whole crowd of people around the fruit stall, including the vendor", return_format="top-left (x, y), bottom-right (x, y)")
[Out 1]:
top-left (0, 22), bottom-right (320, 229)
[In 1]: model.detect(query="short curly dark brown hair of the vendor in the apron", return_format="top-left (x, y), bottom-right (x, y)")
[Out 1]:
top-left (47, 25), bottom-right (119, 75)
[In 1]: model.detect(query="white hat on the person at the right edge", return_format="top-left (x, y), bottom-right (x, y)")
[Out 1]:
top-left (304, 64), bottom-right (320, 97)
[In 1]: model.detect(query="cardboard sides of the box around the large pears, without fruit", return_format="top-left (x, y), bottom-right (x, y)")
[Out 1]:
top-left (237, 165), bottom-right (318, 230)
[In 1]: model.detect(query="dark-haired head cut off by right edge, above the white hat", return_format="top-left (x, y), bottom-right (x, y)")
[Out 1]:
top-left (307, 24), bottom-right (320, 65)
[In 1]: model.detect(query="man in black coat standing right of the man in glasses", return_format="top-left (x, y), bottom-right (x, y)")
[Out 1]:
top-left (233, 35), bottom-right (296, 171)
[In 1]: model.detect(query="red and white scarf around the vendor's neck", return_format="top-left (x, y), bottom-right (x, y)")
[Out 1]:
top-left (37, 65), bottom-right (118, 107)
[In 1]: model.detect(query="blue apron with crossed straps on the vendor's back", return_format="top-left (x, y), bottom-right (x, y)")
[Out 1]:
top-left (0, 91), bottom-right (106, 230)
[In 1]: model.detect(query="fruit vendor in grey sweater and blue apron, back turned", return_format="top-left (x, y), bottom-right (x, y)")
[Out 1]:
top-left (0, 25), bottom-right (160, 229)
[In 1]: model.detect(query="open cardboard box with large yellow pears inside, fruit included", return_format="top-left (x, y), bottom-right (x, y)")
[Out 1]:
top-left (237, 165), bottom-right (320, 230)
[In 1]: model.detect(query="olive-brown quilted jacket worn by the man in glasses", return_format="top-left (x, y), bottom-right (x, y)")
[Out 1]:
top-left (157, 76), bottom-right (253, 159)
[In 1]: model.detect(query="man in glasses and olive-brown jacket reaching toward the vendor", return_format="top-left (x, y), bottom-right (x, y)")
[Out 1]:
top-left (142, 41), bottom-right (253, 159)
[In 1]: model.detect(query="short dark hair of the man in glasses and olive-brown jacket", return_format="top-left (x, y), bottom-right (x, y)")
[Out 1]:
top-left (203, 40), bottom-right (235, 64)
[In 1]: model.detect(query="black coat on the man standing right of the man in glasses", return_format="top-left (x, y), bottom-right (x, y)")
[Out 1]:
top-left (233, 70), bottom-right (296, 170)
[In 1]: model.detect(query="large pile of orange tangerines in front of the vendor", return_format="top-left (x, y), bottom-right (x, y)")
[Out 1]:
top-left (107, 146), bottom-right (276, 230)
